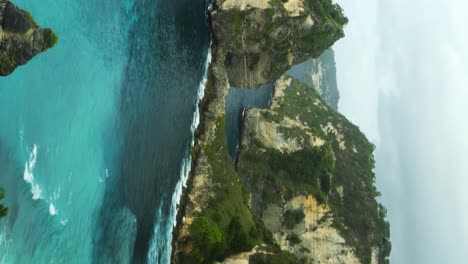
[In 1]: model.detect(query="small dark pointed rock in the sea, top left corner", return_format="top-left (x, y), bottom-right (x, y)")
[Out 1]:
top-left (0, 0), bottom-right (57, 76)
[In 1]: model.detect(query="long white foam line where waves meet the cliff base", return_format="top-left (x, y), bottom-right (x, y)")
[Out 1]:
top-left (147, 44), bottom-right (211, 263)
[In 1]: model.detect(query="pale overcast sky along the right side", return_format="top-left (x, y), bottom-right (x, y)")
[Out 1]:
top-left (334, 0), bottom-right (468, 264)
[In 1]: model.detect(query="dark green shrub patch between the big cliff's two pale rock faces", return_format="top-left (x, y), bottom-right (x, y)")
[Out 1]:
top-left (239, 139), bottom-right (335, 207)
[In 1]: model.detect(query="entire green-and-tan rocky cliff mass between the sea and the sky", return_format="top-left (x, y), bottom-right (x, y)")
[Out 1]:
top-left (172, 0), bottom-right (386, 263)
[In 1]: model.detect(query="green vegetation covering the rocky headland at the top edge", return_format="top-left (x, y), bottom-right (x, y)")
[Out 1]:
top-left (215, 0), bottom-right (347, 85)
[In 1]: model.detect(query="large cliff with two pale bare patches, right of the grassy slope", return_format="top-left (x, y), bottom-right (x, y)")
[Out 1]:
top-left (237, 75), bottom-right (388, 263)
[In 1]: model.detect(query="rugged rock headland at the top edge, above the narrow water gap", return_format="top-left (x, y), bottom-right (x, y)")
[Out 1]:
top-left (212, 0), bottom-right (347, 88)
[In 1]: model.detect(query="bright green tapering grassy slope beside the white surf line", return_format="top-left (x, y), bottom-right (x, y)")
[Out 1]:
top-left (182, 116), bottom-right (273, 263)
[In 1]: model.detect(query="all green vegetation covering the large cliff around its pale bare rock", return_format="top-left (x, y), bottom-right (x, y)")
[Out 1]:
top-left (238, 77), bottom-right (391, 263)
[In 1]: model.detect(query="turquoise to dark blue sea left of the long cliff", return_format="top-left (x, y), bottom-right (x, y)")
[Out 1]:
top-left (0, 0), bottom-right (209, 263)
